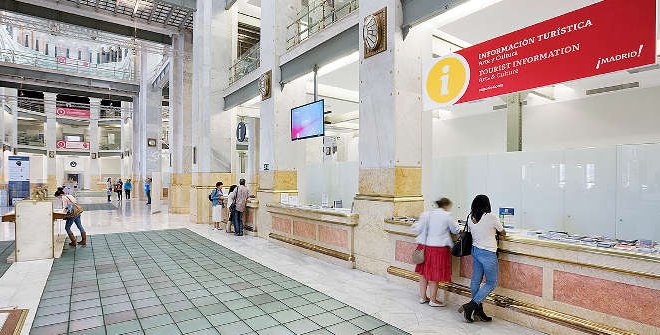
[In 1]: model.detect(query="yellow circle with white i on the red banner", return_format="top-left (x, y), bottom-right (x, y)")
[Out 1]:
top-left (425, 54), bottom-right (470, 105)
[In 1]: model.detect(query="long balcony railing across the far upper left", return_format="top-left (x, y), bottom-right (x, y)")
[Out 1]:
top-left (0, 49), bottom-right (136, 81)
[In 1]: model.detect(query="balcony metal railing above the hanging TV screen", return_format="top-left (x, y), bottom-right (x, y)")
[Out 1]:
top-left (286, 0), bottom-right (360, 50)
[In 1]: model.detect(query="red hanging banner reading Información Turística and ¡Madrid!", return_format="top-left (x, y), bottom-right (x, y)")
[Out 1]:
top-left (422, 0), bottom-right (656, 110)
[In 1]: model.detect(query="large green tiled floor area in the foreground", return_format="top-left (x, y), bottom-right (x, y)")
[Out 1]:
top-left (30, 229), bottom-right (406, 335)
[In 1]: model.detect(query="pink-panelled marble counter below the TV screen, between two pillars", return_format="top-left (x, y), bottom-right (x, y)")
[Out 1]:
top-left (266, 203), bottom-right (358, 268)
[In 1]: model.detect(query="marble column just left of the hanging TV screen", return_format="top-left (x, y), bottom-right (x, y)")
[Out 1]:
top-left (258, 1), bottom-right (309, 237)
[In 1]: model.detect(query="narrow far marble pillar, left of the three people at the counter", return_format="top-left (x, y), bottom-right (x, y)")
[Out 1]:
top-left (168, 33), bottom-right (193, 214)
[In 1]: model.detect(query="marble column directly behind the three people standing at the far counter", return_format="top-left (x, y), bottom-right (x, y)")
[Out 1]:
top-left (190, 0), bottom-right (238, 223)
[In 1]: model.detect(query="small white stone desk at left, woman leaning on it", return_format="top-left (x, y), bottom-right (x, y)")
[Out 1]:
top-left (2, 200), bottom-right (66, 262)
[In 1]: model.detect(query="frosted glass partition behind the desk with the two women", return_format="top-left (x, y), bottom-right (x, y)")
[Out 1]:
top-left (425, 143), bottom-right (660, 240)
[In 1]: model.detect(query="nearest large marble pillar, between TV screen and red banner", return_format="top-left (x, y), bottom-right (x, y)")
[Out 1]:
top-left (354, 0), bottom-right (431, 274)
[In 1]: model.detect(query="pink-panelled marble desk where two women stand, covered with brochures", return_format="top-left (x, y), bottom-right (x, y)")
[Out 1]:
top-left (385, 220), bottom-right (660, 334)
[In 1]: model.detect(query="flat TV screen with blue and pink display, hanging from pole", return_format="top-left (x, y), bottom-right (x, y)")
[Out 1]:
top-left (291, 100), bottom-right (325, 141)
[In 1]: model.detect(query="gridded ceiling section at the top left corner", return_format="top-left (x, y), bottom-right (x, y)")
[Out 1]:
top-left (38, 0), bottom-right (195, 30)
